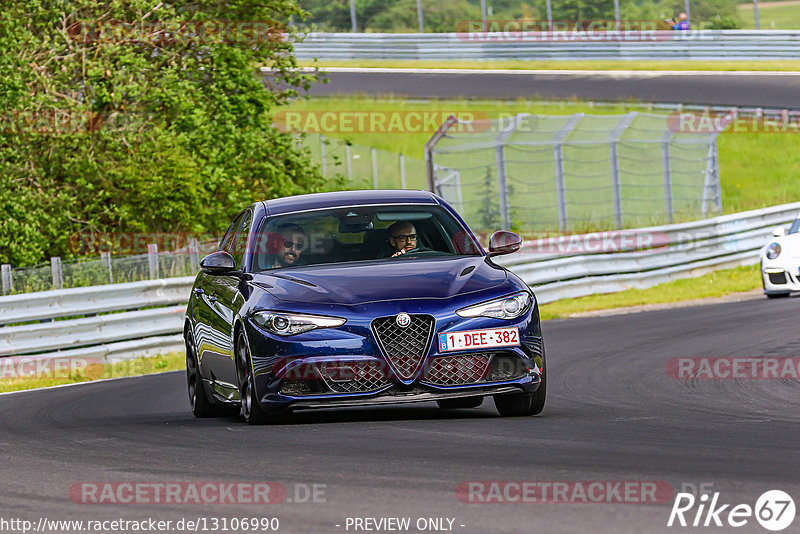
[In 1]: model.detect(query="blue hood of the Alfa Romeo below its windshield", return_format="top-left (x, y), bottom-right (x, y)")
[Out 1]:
top-left (253, 256), bottom-right (507, 305)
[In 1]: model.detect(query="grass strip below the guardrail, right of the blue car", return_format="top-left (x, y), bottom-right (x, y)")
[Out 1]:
top-left (533, 265), bottom-right (761, 319)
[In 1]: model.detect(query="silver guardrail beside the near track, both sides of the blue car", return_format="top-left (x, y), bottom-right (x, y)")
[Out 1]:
top-left (0, 202), bottom-right (800, 361)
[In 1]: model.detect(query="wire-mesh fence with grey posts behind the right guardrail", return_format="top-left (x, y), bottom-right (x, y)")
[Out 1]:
top-left (426, 112), bottom-right (722, 232)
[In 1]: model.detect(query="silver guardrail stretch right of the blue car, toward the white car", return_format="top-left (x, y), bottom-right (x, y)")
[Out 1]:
top-left (498, 202), bottom-right (800, 303)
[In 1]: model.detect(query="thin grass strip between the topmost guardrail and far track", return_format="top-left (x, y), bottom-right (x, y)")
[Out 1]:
top-left (300, 60), bottom-right (800, 71)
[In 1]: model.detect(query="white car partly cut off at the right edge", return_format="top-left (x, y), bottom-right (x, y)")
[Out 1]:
top-left (761, 215), bottom-right (800, 298)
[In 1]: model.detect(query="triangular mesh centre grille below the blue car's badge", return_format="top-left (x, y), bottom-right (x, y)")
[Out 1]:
top-left (372, 314), bottom-right (433, 380)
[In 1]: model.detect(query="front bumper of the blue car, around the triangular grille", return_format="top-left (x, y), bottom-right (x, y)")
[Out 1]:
top-left (246, 310), bottom-right (544, 412)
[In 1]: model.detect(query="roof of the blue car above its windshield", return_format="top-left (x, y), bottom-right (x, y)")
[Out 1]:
top-left (263, 189), bottom-right (439, 216)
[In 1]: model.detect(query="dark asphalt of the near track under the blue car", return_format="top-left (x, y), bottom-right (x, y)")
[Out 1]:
top-left (0, 298), bottom-right (800, 534)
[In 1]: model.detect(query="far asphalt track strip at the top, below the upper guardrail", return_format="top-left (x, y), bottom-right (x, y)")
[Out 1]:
top-left (310, 69), bottom-right (800, 108)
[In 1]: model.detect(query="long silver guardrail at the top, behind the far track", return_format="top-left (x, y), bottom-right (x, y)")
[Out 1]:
top-left (294, 30), bottom-right (800, 61)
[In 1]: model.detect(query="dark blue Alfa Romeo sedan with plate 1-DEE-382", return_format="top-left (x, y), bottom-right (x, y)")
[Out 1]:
top-left (184, 191), bottom-right (547, 424)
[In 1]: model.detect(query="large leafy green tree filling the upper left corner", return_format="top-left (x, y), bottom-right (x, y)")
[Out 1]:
top-left (0, 0), bottom-right (323, 265)
